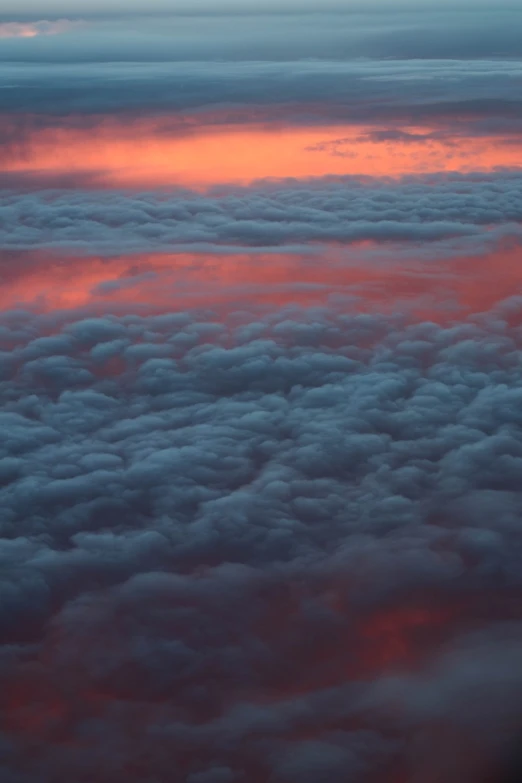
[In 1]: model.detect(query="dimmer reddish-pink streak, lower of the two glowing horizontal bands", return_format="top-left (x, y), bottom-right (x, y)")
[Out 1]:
top-left (0, 247), bottom-right (522, 320)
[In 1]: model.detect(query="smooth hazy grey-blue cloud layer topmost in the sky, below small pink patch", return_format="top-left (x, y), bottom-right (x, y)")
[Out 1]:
top-left (2, 6), bottom-right (522, 62)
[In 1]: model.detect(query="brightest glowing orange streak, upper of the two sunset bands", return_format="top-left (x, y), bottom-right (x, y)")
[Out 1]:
top-left (3, 120), bottom-right (522, 189)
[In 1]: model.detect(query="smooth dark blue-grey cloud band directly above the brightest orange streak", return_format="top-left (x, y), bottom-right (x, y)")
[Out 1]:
top-left (0, 58), bottom-right (521, 118)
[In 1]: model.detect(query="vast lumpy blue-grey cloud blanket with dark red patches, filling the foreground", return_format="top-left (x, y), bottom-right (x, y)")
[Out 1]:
top-left (0, 301), bottom-right (522, 783)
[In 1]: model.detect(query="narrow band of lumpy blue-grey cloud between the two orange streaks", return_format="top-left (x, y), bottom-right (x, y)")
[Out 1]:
top-left (0, 172), bottom-right (522, 253)
